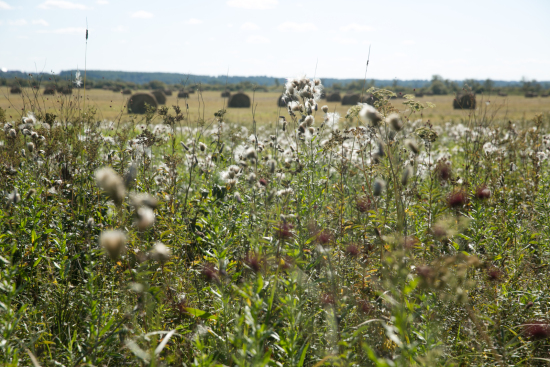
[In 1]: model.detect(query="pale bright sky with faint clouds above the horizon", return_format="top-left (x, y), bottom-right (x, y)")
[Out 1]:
top-left (0, 0), bottom-right (550, 81)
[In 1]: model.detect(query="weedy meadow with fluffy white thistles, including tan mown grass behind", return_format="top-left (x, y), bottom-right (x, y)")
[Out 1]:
top-left (0, 77), bottom-right (550, 367)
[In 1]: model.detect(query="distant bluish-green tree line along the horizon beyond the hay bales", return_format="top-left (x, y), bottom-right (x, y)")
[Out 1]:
top-left (0, 70), bottom-right (550, 95)
